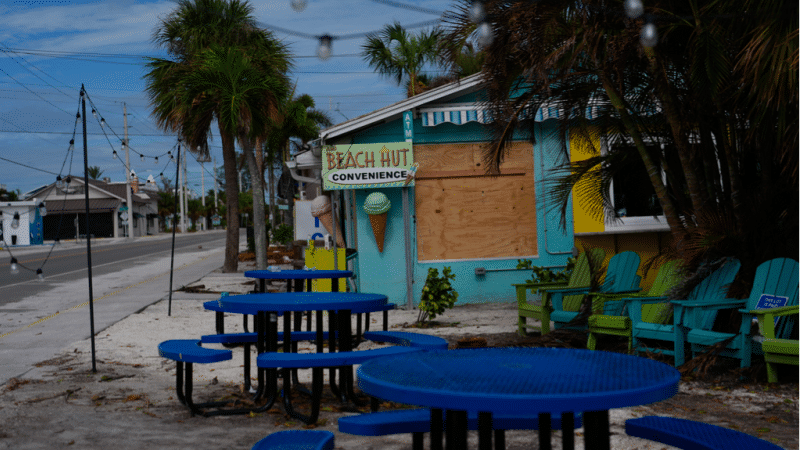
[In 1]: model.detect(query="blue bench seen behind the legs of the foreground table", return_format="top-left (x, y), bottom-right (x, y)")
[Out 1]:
top-left (339, 408), bottom-right (583, 450)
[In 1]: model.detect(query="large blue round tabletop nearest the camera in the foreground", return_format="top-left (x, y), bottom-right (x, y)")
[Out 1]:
top-left (357, 347), bottom-right (680, 414)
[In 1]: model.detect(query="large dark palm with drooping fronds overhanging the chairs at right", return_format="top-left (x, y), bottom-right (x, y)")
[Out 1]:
top-left (440, 0), bottom-right (800, 288)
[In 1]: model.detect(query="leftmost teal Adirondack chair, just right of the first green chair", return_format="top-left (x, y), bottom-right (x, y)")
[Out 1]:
top-left (542, 252), bottom-right (641, 328)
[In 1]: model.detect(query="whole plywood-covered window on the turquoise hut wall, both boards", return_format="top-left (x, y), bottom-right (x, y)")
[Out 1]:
top-left (414, 142), bottom-right (537, 261)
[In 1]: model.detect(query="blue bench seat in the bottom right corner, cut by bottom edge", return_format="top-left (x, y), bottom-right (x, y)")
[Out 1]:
top-left (625, 416), bottom-right (782, 450)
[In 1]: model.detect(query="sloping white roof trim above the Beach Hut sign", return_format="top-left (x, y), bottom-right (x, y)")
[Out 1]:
top-left (319, 73), bottom-right (483, 139)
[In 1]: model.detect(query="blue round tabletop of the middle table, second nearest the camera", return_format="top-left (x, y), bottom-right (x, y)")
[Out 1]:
top-left (217, 292), bottom-right (388, 315)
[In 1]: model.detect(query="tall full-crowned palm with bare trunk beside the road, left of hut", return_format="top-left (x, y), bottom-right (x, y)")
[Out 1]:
top-left (145, 0), bottom-right (289, 272)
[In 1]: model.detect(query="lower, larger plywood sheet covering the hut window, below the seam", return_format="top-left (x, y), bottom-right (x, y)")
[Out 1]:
top-left (416, 175), bottom-right (537, 261)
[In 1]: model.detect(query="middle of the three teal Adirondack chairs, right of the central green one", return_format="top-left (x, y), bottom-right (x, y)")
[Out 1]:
top-left (628, 259), bottom-right (742, 360)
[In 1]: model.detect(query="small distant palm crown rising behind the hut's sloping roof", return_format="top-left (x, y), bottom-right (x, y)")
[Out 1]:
top-left (361, 22), bottom-right (440, 97)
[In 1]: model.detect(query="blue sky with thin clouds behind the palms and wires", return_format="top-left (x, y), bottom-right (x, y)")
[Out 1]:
top-left (0, 0), bottom-right (453, 197)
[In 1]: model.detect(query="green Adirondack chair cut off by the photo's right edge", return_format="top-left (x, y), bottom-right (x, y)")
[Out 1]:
top-left (750, 305), bottom-right (800, 383)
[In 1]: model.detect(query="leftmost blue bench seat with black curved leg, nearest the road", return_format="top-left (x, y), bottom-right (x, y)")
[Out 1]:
top-left (158, 339), bottom-right (241, 416)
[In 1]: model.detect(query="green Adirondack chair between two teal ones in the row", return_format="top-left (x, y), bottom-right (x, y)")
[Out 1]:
top-left (586, 260), bottom-right (681, 353)
